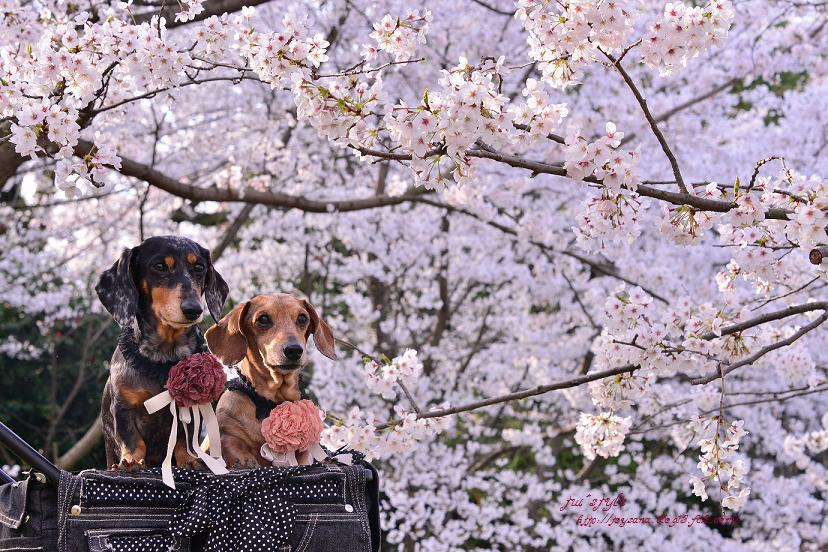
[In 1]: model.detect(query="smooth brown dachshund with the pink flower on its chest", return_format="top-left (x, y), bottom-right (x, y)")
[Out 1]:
top-left (205, 293), bottom-right (336, 468)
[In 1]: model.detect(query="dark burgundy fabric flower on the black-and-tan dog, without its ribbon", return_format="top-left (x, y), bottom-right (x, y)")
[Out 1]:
top-left (167, 353), bottom-right (227, 407)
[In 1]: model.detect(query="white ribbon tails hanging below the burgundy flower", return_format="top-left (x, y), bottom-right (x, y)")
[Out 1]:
top-left (144, 390), bottom-right (228, 489)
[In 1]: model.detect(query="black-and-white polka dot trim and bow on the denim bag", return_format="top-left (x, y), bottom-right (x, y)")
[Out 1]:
top-left (82, 465), bottom-right (345, 552)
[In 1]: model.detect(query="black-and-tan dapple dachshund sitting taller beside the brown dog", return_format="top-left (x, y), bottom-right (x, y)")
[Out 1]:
top-left (95, 236), bottom-right (228, 470)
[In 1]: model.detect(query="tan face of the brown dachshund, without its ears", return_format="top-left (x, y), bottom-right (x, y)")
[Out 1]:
top-left (243, 293), bottom-right (310, 372)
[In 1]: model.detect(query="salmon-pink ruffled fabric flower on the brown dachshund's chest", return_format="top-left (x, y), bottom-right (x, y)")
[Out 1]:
top-left (262, 400), bottom-right (322, 454)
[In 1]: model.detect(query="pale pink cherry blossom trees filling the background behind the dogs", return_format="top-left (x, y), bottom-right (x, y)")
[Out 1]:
top-left (0, 0), bottom-right (828, 550)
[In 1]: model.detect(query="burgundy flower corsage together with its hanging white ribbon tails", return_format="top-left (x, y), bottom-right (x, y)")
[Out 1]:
top-left (144, 353), bottom-right (228, 489)
